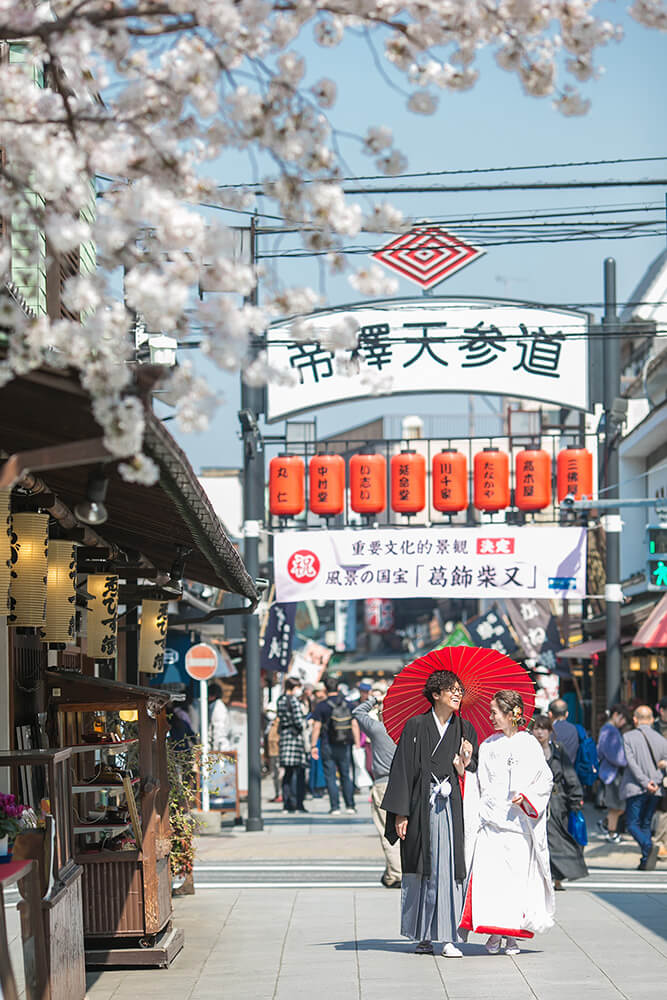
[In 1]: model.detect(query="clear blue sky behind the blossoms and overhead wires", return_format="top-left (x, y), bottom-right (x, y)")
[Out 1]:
top-left (168, 10), bottom-right (667, 470)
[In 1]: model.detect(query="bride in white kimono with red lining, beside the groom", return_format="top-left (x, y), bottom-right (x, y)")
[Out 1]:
top-left (460, 691), bottom-right (555, 955)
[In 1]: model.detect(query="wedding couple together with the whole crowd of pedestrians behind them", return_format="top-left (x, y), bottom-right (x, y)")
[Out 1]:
top-left (260, 670), bottom-right (667, 958)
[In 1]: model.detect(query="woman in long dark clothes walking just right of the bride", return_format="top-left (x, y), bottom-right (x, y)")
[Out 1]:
top-left (532, 715), bottom-right (588, 889)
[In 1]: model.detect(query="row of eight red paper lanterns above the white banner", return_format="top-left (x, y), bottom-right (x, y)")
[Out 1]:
top-left (269, 446), bottom-right (593, 517)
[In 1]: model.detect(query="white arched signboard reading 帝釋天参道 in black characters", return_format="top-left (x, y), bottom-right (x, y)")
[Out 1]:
top-left (267, 296), bottom-right (590, 421)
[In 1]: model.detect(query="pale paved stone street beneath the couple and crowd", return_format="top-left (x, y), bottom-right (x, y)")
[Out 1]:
top-left (78, 797), bottom-right (667, 1000)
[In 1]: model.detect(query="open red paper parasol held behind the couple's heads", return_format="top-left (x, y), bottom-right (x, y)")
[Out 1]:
top-left (382, 646), bottom-right (535, 743)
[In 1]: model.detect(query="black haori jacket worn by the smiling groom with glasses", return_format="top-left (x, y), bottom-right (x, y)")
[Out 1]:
top-left (382, 709), bottom-right (478, 882)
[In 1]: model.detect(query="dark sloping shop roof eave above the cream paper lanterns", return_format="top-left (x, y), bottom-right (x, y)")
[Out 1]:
top-left (0, 370), bottom-right (257, 601)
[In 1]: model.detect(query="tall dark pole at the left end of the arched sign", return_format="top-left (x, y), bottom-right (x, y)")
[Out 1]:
top-left (239, 218), bottom-right (264, 832)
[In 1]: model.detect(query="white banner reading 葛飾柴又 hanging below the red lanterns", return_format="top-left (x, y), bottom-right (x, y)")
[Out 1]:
top-left (274, 524), bottom-right (586, 601)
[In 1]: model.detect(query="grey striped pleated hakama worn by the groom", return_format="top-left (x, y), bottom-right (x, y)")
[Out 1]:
top-left (401, 795), bottom-right (465, 943)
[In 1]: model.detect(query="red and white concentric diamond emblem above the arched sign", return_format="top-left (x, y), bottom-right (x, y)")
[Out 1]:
top-left (372, 226), bottom-right (484, 288)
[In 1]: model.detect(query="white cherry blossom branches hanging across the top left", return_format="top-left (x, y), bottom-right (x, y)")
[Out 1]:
top-left (0, 0), bottom-right (667, 482)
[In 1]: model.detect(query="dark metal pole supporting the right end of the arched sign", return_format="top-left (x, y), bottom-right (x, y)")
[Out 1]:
top-left (602, 257), bottom-right (623, 706)
